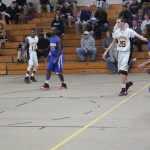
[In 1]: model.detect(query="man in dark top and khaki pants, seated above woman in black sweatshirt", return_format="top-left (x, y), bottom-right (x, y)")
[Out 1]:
top-left (60, 2), bottom-right (73, 27)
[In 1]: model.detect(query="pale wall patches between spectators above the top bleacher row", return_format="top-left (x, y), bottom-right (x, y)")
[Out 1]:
top-left (3, 0), bottom-right (122, 6)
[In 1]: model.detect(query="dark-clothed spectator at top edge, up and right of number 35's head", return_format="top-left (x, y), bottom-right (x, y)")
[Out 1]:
top-left (129, 0), bottom-right (140, 17)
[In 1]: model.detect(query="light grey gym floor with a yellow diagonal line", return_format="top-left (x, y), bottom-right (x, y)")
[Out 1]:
top-left (0, 73), bottom-right (150, 150)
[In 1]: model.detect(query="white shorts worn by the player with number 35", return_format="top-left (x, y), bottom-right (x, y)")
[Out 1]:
top-left (118, 51), bottom-right (130, 72)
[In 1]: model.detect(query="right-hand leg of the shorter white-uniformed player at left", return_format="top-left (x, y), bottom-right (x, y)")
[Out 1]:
top-left (30, 53), bottom-right (38, 82)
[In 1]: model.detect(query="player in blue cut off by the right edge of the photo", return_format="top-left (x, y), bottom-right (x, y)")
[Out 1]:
top-left (138, 24), bottom-right (150, 74)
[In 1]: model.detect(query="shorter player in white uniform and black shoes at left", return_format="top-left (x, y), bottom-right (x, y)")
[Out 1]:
top-left (24, 29), bottom-right (38, 83)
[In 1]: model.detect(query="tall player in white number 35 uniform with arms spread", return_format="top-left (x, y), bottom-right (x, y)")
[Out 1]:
top-left (103, 18), bottom-right (145, 96)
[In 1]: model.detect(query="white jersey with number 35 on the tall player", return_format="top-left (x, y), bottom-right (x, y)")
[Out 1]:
top-left (113, 28), bottom-right (136, 51)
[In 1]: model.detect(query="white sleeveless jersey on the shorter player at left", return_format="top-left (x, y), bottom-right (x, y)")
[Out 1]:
top-left (27, 36), bottom-right (39, 51)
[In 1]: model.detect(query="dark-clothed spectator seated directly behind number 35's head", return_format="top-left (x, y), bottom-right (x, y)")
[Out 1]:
top-left (118, 5), bottom-right (133, 27)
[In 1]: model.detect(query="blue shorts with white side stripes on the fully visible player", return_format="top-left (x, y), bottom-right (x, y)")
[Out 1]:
top-left (47, 54), bottom-right (64, 73)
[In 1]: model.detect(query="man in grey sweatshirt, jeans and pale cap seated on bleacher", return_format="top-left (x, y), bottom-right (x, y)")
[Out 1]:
top-left (76, 31), bottom-right (97, 62)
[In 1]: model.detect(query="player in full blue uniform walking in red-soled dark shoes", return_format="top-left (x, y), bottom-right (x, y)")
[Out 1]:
top-left (40, 27), bottom-right (67, 90)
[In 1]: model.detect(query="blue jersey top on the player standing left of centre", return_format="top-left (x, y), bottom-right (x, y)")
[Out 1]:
top-left (50, 36), bottom-right (60, 57)
